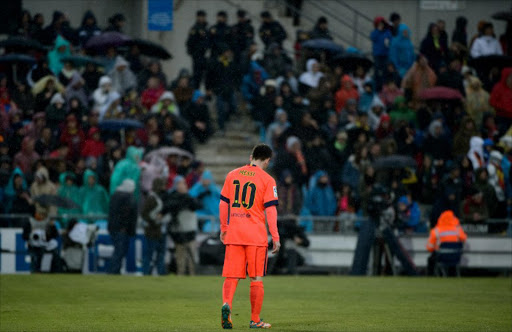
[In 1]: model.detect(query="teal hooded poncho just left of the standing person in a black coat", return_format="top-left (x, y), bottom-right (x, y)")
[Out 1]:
top-left (79, 169), bottom-right (109, 214)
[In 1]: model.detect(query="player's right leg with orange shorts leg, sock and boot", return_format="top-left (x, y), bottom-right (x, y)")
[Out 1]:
top-left (247, 246), bottom-right (271, 329)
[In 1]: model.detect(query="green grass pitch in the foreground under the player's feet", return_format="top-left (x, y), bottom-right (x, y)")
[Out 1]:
top-left (0, 275), bottom-right (512, 332)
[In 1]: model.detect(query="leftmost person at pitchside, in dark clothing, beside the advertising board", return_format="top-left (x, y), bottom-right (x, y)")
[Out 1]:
top-left (22, 207), bottom-right (60, 273)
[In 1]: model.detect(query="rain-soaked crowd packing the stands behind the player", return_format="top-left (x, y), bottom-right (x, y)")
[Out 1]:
top-left (0, 10), bottom-right (512, 273)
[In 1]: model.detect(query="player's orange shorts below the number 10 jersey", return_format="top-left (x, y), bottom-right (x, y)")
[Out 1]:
top-left (222, 244), bottom-right (268, 279)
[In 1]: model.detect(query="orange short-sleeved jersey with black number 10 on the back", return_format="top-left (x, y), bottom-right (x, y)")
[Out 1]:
top-left (220, 165), bottom-right (278, 246)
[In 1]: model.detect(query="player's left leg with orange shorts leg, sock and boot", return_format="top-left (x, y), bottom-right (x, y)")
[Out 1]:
top-left (221, 245), bottom-right (247, 329)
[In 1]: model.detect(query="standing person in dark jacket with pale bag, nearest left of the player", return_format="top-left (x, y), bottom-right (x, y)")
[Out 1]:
top-left (164, 175), bottom-right (201, 275)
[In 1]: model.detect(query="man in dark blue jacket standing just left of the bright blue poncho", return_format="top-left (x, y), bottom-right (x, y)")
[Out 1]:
top-left (370, 16), bottom-right (393, 91)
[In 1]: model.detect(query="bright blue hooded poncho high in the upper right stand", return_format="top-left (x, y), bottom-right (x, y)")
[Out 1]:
top-left (389, 24), bottom-right (416, 77)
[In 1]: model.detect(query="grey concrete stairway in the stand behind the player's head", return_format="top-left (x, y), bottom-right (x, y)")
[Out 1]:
top-left (196, 110), bottom-right (259, 185)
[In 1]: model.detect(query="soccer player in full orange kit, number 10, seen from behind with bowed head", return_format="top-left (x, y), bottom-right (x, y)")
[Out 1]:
top-left (219, 144), bottom-right (281, 329)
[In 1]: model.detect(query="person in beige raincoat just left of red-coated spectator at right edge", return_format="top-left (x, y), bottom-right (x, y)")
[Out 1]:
top-left (466, 76), bottom-right (490, 128)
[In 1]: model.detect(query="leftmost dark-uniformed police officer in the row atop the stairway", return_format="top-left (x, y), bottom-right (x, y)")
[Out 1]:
top-left (186, 10), bottom-right (210, 89)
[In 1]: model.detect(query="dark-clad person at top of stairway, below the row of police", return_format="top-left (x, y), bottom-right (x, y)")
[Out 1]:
top-left (206, 44), bottom-right (237, 133)
